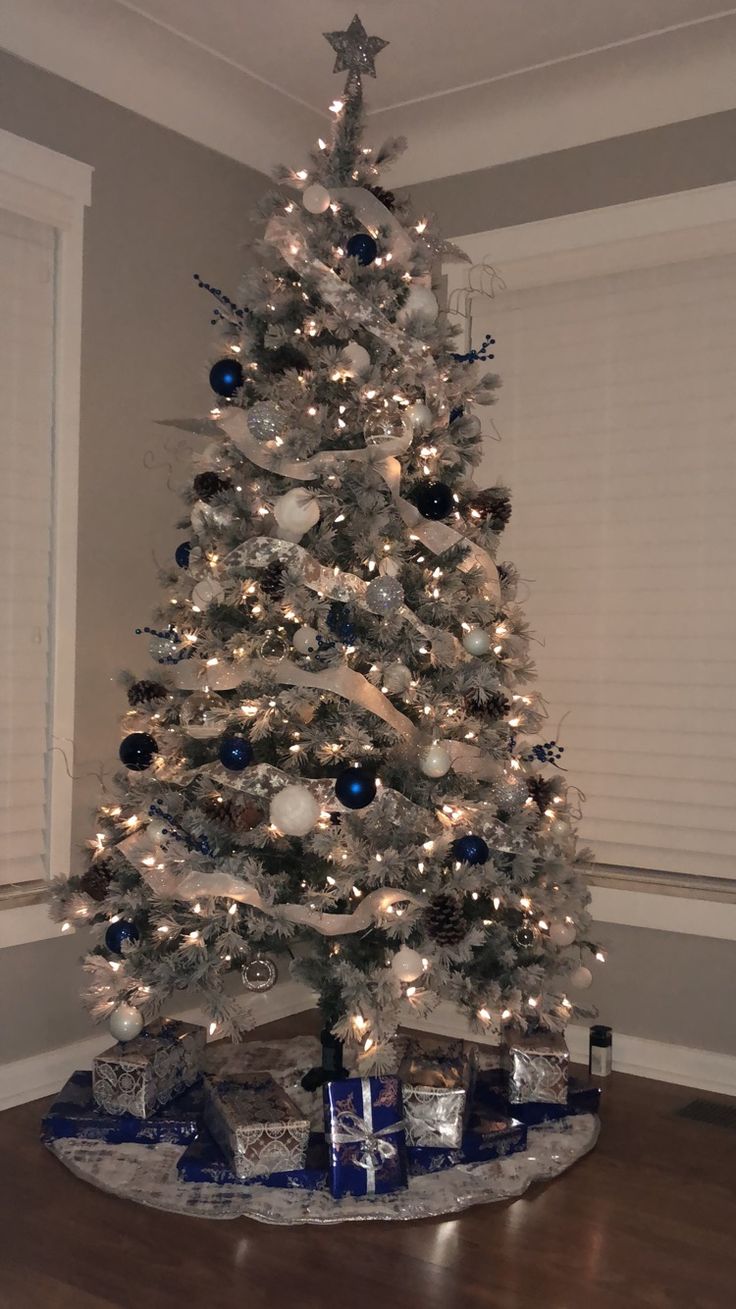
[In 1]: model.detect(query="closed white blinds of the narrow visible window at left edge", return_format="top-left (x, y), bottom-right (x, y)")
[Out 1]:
top-left (0, 209), bottom-right (55, 884)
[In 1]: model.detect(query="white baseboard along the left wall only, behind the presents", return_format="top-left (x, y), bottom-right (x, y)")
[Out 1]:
top-left (0, 980), bottom-right (314, 1110)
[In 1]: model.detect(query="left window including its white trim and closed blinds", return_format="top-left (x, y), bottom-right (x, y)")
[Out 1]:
top-left (0, 132), bottom-right (90, 944)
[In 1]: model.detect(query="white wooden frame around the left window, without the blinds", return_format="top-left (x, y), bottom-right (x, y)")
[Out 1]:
top-left (0, 131), bottom-right (93, 948)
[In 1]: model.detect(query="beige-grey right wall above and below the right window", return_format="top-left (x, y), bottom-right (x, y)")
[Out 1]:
top-left (411, 110), bottom-right (736, 1055)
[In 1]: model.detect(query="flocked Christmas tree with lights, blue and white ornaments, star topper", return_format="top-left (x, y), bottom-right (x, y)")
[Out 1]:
top-left (55, 18), bottom-right (595, 1068)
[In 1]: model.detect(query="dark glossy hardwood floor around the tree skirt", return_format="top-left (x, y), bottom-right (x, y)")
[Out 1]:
top-left (0, 1016), bottom-right (736, 1309)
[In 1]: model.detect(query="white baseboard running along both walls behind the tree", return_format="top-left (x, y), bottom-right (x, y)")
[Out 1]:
top-left (0, 980), bottom-right (736, 1110)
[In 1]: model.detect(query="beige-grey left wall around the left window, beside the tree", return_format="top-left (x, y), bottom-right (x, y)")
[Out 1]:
top-left (0, 52), bottom-right (267, 1063)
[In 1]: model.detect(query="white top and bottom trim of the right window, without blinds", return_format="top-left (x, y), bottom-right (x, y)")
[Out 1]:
top-left (443, 182), bottom-right (736, 941)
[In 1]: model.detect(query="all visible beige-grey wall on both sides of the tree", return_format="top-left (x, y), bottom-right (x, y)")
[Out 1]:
top-left (0, 46), bottom-right (736, 1063)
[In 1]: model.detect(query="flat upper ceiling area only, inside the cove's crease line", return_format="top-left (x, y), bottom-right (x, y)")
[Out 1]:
top-left (117, 0), bottom-right (726, 111)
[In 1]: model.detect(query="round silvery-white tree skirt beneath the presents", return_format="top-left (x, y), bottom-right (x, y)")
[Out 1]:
top-left (44, 1037), bottom-right (598, 1225)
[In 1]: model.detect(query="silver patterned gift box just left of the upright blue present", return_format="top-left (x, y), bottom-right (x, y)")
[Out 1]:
top-left (204, 1073), bottom-right (309, 1181)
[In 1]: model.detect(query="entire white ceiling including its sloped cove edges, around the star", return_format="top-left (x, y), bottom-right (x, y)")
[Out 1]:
top-left (0, 0), bottom-right (736, 183)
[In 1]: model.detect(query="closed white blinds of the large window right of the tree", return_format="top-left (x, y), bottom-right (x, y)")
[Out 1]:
top-left (473, 242), bottom-right (736, 878)
